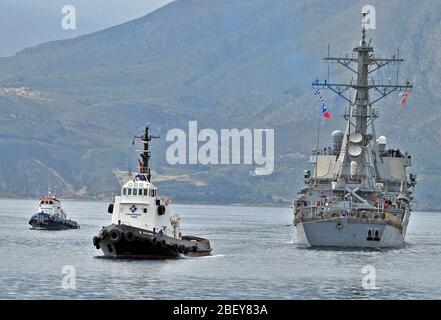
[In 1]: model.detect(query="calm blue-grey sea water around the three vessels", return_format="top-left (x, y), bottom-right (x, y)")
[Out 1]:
top-left (0, 200), bottom-right (441, 299)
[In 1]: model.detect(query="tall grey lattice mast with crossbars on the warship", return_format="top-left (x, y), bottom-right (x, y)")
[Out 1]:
top-left (313, 13), bottom-right (412, 188)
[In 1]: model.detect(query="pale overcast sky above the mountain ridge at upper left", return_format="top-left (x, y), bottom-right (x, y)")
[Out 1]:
top-left (0, 0), bottom-right (172, 57)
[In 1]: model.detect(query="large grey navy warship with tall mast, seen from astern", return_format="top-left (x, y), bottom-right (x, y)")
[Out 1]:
top-left (293, 13), bottom-right (417, 248)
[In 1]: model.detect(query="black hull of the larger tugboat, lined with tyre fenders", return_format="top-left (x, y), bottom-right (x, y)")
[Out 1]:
top-left (93, 224), bottom-right (211, 259)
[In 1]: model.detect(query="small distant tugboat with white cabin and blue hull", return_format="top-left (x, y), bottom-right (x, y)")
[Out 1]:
top-left (29, 186), bottom-right (80, 230)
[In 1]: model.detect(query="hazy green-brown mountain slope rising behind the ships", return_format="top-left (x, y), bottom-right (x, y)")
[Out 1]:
top-left (0, 0), bottom-right (441, 208)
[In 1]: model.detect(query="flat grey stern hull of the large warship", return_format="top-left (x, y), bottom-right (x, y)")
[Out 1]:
top-left (296, 218), bottom-right (405, 249)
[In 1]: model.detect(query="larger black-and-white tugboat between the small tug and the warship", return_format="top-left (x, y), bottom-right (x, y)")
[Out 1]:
top-left (93, 126), bottom-right (211, 259)
